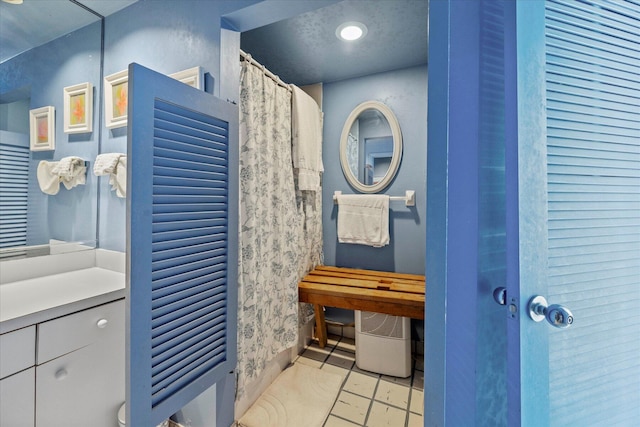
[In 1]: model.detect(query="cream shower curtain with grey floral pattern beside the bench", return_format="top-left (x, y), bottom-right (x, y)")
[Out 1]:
top-left (237, 61), bottom-right (322, 397)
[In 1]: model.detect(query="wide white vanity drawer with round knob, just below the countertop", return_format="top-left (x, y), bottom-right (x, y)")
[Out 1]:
top-left (37, 300), bottom-right (125, 365)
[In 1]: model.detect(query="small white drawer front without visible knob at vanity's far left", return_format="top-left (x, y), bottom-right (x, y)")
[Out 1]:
top-left (0, 326), bottom-right (36, 378)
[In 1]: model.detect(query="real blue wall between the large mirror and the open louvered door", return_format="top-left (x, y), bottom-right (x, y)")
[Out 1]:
top-left (99, 0), bottom-right (257, 251)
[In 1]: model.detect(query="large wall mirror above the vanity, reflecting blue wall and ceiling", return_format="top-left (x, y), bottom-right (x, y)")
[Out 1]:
top-left (0, 0), bottom-right (102, 260)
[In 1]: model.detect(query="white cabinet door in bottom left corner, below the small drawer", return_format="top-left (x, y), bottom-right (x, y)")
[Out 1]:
top-left (0, 368), bottom-right (35, 427)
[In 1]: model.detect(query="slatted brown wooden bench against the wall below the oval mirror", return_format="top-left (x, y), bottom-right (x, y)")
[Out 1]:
top-left (298, 266), bottom-right (426, 347)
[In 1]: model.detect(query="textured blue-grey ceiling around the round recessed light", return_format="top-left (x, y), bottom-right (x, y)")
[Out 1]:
top-left (240, 0), bottom-right (428, 85)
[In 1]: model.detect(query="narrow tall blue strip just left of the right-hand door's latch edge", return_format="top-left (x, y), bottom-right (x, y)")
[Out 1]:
top-left (475, 0), bottom-right (507, 427)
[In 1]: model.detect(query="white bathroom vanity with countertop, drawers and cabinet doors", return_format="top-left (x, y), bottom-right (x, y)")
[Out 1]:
top-left (0, 250), bottom-right (125, 427)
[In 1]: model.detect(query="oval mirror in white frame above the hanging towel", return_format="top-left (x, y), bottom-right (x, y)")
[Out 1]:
top-left (340, 101), bottom-right (402, 193)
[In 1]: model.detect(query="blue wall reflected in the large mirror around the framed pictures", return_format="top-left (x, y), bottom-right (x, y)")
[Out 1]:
top-left (0, 22), bottom-right (100, 249)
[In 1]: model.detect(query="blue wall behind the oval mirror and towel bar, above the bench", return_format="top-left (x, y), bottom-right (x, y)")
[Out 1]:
top-left (322, 65), bottom-right (427, 274)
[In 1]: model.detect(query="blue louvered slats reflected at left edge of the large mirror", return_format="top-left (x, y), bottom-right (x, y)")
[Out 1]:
top-left (0, 143), bottom-right (29, 249)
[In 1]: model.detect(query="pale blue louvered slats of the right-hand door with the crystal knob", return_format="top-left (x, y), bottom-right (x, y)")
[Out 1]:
top-left (545, 0), bottom-right (640, 426)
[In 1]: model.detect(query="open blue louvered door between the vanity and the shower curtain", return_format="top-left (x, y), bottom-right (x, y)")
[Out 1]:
top-left (127, 64), bottom-right (238, 426)
